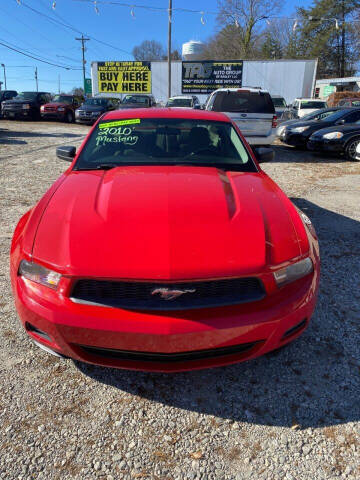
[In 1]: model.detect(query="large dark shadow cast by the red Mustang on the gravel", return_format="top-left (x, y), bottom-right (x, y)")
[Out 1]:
top-left (76, 198), bottom-right (360, 428)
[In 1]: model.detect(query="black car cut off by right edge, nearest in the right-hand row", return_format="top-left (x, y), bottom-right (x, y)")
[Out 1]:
top-left (307, 118), bottom-right (360, 160)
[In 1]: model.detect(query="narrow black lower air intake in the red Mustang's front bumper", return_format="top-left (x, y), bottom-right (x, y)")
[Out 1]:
top-left (76, 341), bottom-right (264, 363)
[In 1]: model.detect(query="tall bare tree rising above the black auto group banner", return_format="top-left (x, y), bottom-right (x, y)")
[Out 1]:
top-left (218, 0), bottom-right (280, 58)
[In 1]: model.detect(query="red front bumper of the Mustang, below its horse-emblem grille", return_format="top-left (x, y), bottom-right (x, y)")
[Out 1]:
top-left (12, 259), bottom-right (319, 372)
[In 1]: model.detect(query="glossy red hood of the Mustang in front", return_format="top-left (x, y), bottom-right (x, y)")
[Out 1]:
top-left (33, 166), bottom-right (309, 280)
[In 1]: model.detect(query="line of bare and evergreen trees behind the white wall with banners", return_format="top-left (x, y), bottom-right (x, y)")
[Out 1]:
top-left (132, 0), bottom-right (360, 78)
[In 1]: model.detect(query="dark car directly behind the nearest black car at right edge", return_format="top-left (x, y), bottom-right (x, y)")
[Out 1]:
top-left (280, 108), bottom-right (360, 148)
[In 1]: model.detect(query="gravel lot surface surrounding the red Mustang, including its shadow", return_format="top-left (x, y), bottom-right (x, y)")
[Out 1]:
top-left (0, 121), bottom-right (360, 480)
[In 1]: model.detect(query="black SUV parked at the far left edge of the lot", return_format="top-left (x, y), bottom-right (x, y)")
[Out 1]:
top-left (2, 92), bottom-right (51, 120)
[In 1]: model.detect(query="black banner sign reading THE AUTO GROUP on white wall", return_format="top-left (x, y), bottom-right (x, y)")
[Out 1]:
top-left (182, 60), bottom-right (243, 93)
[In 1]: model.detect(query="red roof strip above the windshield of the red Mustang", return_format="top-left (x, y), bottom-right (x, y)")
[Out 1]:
top-left (102, 108), bottom-right (231, 123)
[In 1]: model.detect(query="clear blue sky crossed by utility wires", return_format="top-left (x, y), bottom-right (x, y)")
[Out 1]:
top-left (0, 0), bottom-right (312, 93)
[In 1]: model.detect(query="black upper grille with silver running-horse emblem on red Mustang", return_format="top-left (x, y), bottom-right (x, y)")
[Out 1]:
top-left (71, 277), bottom-right (265, 310)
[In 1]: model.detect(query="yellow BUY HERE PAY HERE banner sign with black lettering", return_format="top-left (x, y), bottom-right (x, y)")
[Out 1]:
top-left (97, 62), bottom-right (151, 93)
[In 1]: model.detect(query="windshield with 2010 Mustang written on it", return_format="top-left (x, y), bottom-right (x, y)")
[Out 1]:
top-left (75, 118), bottom-right (257, 172)
